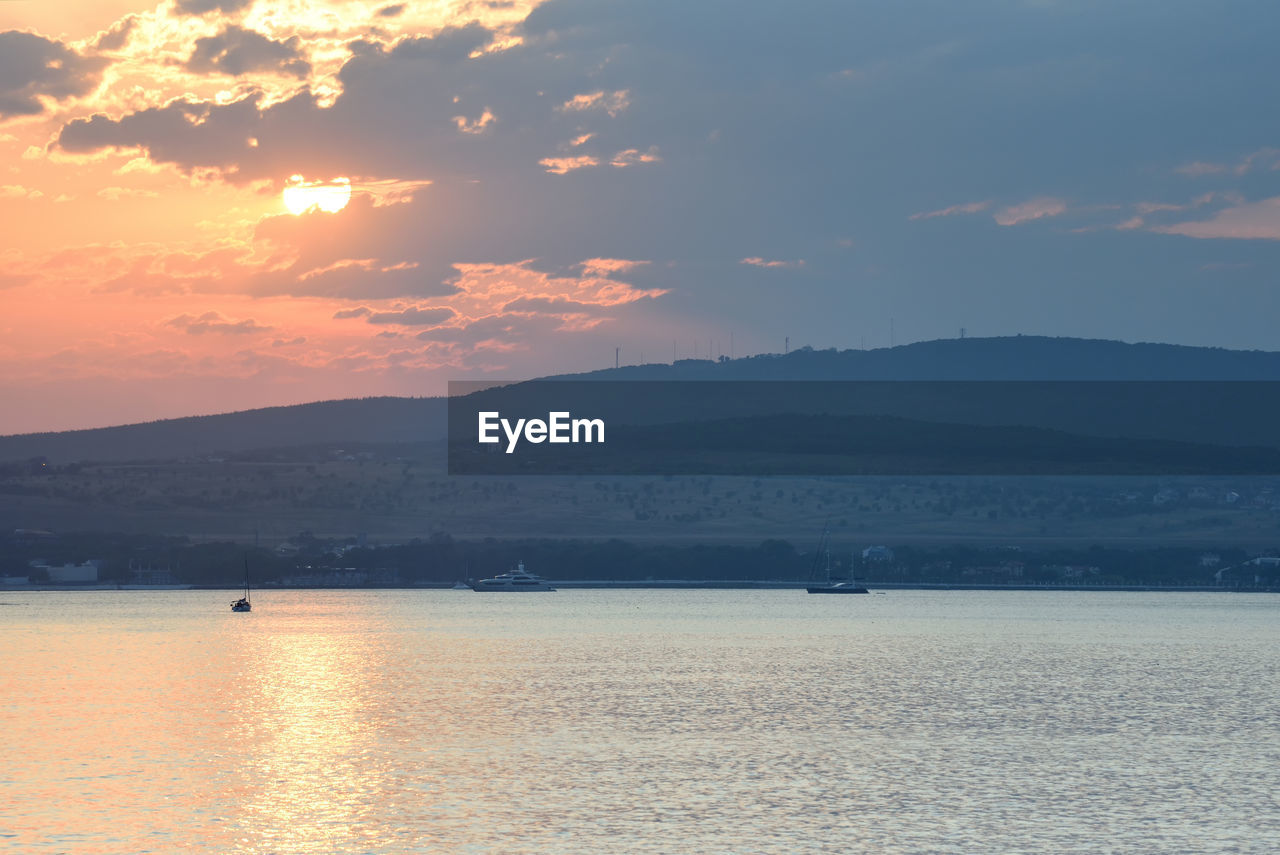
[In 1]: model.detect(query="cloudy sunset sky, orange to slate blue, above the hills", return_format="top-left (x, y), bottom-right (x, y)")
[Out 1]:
top-left (0, 0), bottom-right (1280, 433)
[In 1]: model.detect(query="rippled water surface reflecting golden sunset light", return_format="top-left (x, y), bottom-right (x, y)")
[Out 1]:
top-left (0, 590), bottom-right (1280, 855)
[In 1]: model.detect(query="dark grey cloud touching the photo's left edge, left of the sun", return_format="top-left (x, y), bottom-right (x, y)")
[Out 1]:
top-left (0, 29), bottom-right (106, 120)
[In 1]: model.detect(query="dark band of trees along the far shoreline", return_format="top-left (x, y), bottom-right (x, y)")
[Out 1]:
top-left (0, 532), bottom-right (1280, 590)
